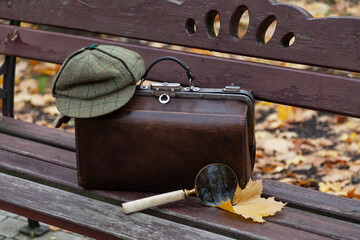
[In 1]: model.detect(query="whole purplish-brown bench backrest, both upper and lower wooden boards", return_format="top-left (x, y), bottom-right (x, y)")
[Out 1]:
top-left (0, 0), bottom-right (360, 117)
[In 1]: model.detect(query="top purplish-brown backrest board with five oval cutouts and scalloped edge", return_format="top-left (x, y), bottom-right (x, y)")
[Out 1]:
top-left (0, 0), bottom-right (360, 71)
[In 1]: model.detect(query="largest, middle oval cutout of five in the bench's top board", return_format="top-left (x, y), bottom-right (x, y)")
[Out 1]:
top-left (230, 6), bottom-right (250, 39)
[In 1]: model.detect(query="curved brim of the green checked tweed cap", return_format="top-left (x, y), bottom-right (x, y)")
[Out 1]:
top-left (56, 85), bottom-right (136, 118)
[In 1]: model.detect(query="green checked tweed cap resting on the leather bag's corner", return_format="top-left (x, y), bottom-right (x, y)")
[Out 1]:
top-left (52, 44), bottom-right (145, 118)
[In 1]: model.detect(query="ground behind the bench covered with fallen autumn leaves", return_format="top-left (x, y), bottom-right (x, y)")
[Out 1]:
top-left (0, 0), bottom-right (360, 199)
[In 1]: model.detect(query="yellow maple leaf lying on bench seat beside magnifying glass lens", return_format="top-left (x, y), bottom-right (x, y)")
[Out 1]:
top-left (217, 179), bottom-right (286, 223)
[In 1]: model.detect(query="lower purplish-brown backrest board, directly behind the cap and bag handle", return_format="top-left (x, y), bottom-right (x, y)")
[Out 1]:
top-left (0, 25), bottom-right (360, 117)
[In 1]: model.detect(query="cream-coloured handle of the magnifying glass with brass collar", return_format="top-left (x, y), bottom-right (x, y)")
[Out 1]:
top-left (122, 189), bottom-right (195, 214)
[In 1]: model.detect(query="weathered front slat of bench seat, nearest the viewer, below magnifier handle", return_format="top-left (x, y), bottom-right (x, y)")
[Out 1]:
top-left (0, 173), bottom-right (240, 240)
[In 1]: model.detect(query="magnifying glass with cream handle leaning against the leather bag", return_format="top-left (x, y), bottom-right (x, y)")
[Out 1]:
top-left (122, 163), bottom-right (238, 214)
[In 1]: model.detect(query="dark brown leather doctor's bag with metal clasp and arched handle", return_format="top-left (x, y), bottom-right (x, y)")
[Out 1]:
top-left (75, 57), bottom-right (255, 192)
